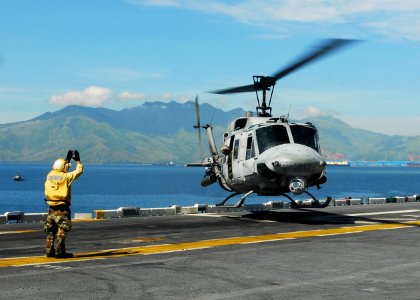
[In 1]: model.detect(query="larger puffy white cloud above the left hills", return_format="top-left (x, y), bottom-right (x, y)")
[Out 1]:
top-left (49, 86), bottom-right (112, 107)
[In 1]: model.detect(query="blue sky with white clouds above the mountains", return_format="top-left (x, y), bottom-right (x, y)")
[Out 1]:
top-left (0, 0), bottom-right (420, 136)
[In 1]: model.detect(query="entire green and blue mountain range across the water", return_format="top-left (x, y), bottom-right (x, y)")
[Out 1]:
top-left (0, 102), bottom-right (420, 163)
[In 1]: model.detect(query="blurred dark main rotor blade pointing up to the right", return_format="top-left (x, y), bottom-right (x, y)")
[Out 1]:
top-left (271, 39), bottom-right (356, 81)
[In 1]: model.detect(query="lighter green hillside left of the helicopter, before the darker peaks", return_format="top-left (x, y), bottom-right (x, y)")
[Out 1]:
top-left (0, 103), bottom-right (236, 163)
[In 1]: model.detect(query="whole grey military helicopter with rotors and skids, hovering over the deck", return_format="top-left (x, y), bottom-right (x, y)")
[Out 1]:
top-left (187, 39), bottom-right (355, 208)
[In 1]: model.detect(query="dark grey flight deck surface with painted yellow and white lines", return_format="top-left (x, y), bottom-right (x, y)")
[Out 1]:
top-left (0, 202), bottom-right (420, 299)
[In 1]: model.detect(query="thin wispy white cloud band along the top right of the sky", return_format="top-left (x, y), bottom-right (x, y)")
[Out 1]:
top-left (127, 0), bottom-right (420, 41)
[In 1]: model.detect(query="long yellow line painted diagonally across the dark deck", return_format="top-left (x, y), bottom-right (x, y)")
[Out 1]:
top-left (0, 221), bottom-right (420, 268)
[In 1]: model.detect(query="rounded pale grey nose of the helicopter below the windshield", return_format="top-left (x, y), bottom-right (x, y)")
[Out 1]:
top-left (263, 144), bottom-right (326, 176)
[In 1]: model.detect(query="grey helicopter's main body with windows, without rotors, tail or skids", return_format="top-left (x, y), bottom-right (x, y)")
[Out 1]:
top-left (219, 117), bottom-right (326, 195)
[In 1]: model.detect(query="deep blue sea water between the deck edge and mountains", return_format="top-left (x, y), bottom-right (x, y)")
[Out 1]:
top-left (0, 164), bottom-right (420, 214)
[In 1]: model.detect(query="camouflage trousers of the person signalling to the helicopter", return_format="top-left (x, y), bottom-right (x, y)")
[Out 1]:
top-left (44, 205), bottom-right (71, 256)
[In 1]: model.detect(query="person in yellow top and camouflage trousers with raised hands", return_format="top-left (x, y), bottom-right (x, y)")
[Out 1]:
top-left (44, 150), bottom-right (83, 258)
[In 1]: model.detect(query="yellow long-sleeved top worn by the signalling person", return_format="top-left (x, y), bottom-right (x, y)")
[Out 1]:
top-left (45, 163), bottom-right (83, 206)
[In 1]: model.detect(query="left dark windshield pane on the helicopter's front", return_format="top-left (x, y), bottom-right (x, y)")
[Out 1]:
top-left (256, 125), bottom-right (290, 154)
